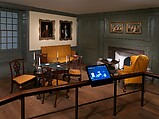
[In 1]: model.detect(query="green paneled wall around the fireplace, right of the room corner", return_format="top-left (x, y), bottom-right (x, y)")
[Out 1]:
top-left (78, 9), bottom-right (159, 73)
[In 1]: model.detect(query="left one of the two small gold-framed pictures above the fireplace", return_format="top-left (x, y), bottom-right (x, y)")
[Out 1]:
top-left (110, 22), bottom-right (124, 33)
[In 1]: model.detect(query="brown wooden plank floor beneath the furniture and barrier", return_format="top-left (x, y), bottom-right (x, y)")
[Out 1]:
top-left (0, 71), bottom-right (159, 119)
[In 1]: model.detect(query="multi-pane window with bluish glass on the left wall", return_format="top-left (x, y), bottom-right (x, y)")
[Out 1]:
top-left (0, 11), bottom-right (18, 50)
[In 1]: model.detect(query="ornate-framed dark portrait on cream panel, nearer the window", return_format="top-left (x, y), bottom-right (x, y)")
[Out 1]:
top-left (39, 19), bottom-right (55, 40)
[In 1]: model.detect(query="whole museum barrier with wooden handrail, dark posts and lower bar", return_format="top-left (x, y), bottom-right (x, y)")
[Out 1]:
top-left (0, 72), bottom-right (159, 119)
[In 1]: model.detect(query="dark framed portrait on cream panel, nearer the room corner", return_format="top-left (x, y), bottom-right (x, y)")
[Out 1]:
top-left (60, 20), bottom-right (72, 40)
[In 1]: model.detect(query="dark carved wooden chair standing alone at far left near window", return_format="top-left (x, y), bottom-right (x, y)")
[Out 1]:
top-left (9, 58), bottom-right (36, 93)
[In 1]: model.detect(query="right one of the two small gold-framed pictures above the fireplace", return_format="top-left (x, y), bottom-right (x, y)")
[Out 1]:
top-left (126, 22), bottom-right (142, 34)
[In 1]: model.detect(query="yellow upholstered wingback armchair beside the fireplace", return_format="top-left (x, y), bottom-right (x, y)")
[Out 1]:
top-left (118, 55), bottom-right (149, 88)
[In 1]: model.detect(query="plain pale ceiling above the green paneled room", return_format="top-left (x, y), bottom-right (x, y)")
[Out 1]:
top-left (0, 0), bottom-right (159, 14)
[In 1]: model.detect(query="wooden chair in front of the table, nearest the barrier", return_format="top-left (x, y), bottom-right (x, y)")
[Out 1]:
top-left (41, 67), bottom-right (69, 107)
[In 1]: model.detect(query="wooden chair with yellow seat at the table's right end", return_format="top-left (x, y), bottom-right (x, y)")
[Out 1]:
top-left (68, 55), bottom-right (82, 81)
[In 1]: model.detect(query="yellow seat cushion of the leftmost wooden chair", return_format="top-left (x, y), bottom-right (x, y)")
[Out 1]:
top-left (13, 74), bottom-right (35, 84)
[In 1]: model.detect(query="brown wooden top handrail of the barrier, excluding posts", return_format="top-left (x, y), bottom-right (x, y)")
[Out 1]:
top-left (0, 72), bottom-right (150, 106)
